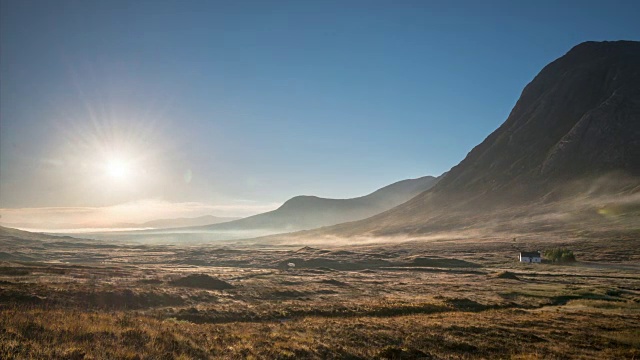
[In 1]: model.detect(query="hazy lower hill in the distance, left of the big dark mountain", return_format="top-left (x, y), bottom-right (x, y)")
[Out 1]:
top-left (174, 176), bottom-right (439, 234)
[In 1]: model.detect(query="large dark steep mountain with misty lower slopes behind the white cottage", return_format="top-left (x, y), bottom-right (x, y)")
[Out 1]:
top-left (270, 41), bottom-right (640, 237)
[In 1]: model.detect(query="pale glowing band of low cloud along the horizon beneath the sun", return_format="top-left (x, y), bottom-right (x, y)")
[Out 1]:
top-left (0, 199), bottom-right (280, 229)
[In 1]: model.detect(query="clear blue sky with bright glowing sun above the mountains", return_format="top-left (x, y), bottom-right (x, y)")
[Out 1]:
top-left (0, 0), bottom-right (640, 222)
